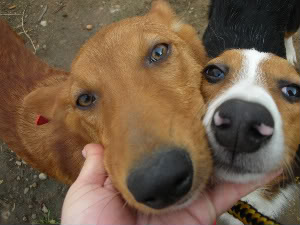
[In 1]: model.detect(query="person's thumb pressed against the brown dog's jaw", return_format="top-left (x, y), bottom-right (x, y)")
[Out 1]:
top-left (77, 144), bottom-right (107, 186)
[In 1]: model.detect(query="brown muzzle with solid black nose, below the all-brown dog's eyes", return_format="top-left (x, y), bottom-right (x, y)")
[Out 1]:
top-left (105, 99), bottom-right (211, 213)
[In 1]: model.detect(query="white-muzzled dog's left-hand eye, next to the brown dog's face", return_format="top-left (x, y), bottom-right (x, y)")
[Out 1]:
top-left (203, 65), bottom-right (228, 83)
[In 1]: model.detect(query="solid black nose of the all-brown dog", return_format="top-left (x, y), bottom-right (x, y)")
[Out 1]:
top-left (127, 148), bottom-right (193, 209)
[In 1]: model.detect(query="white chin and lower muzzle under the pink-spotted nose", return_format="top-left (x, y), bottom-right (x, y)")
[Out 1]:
top-left (208, 132), bottom-right (283, 183)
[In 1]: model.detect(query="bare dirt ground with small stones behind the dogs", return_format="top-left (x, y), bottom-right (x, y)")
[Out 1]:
top-left (0, 0), bottom-right (299, 224)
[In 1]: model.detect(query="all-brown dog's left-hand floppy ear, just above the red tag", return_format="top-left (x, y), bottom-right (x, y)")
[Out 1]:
top-left (24, 81), bottom-right (69, 121)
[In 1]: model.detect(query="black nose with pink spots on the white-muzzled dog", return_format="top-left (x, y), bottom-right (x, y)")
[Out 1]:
top-left (212, 99), bottom-right (274, 153)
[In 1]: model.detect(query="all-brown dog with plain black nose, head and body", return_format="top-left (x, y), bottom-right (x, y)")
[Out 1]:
top-left (0, 1), bottom-right (212, 213)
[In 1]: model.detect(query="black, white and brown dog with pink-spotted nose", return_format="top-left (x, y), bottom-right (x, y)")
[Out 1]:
top-left (202, 0), bottom-right (300, 224)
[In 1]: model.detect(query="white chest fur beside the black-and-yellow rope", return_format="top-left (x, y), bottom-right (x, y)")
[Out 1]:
top-left (217, 184), bottom-right (299, 225)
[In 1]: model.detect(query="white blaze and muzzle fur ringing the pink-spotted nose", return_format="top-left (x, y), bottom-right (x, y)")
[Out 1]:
top-left (204, 50), bottom-right (284, 183)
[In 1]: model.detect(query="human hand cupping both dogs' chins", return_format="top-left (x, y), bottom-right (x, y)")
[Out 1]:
top-left (62, 144), bottom-right (280, 225)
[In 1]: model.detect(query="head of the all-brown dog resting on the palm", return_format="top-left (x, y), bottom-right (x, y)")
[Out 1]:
top-left (26, 1), bottom-right (212, 213)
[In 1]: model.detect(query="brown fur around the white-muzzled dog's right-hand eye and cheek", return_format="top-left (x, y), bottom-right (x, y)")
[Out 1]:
top-left (261, 56), bottom-right (300, 199)
